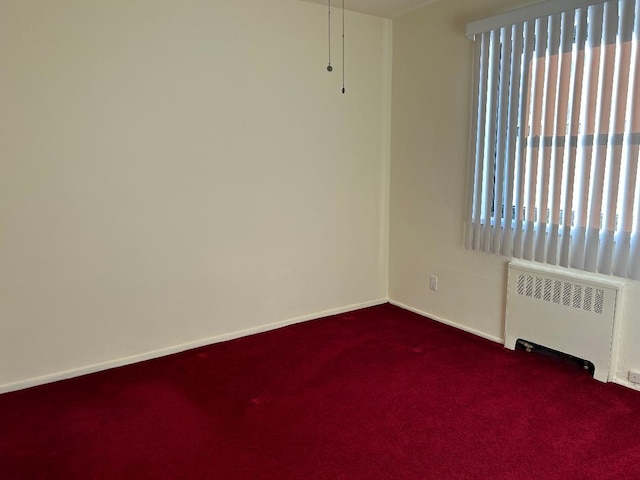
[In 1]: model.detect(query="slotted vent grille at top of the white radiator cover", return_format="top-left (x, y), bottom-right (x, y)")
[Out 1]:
top-left (516, 273), bottom-right (604, 315)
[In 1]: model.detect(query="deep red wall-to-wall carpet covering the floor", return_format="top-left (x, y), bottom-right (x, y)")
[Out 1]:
top-left (0, 305), bottom-right (640, 480)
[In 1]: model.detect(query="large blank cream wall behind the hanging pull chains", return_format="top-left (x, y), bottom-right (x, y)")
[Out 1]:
top-left (0, 0), bottom-right (391, 390)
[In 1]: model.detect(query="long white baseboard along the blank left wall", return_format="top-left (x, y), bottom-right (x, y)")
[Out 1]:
top-left (0, 298), bottom-right (388, 394)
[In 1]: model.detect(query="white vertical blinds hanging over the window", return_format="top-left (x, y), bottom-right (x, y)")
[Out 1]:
top-left (466, 0), bottom-right (640, 279)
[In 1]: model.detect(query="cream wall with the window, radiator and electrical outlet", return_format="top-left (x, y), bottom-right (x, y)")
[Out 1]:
top-left (389, 0), bottom-right (640, 390)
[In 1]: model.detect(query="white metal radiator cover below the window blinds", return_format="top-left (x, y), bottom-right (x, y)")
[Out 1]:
top-left (505, 260), bottom-right (624, 382)
